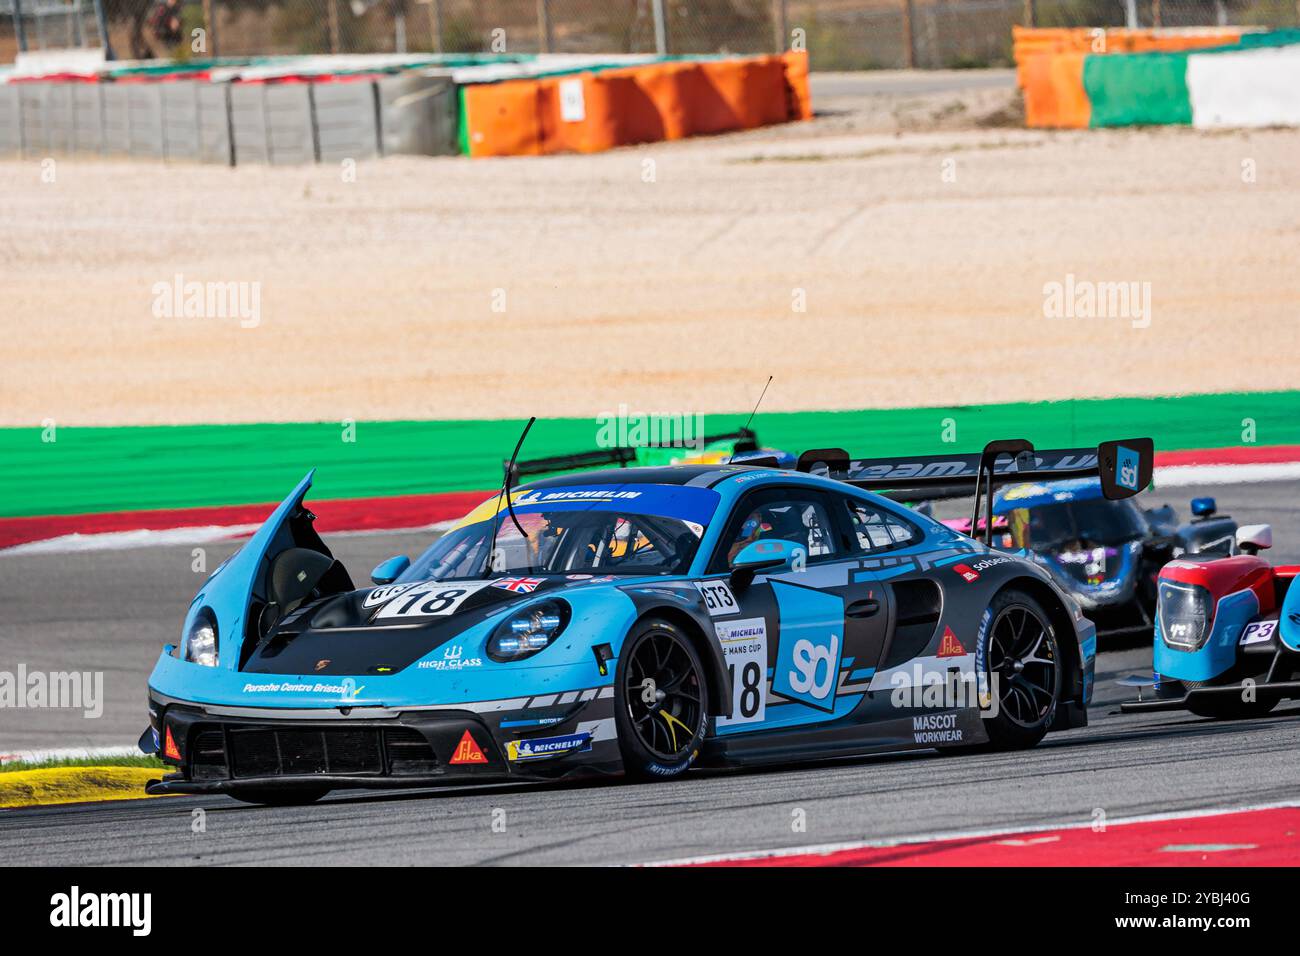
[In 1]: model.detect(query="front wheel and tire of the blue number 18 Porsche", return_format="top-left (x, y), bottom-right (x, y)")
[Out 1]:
top-left (614, 619), bottom-right (709, 780)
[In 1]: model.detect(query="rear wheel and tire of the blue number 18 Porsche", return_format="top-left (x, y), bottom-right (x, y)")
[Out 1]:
top-left (975, 588), bottom-right (1061, 750)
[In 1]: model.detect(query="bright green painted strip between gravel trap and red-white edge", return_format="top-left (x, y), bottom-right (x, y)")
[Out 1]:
top-left (0, 392), bottom-right (1300, 518)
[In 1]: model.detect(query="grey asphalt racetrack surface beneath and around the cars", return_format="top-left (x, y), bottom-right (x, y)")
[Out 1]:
top-left (0, 483), bottom-right (1300, 865)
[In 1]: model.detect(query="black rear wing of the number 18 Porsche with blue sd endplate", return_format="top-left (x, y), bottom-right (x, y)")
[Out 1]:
top-left (796, 438), bottom-right (1154, 541)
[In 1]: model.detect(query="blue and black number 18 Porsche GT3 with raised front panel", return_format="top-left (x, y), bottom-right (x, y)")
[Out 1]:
top-left (140, 440), bottom-right (1152, 804)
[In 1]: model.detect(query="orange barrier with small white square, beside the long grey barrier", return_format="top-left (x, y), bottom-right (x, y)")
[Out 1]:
top-left (464, 53), bottom-right (811, 156)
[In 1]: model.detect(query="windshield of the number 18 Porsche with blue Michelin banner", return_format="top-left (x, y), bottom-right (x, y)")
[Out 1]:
top-left (398, 485), bottom-right (718, 583)
